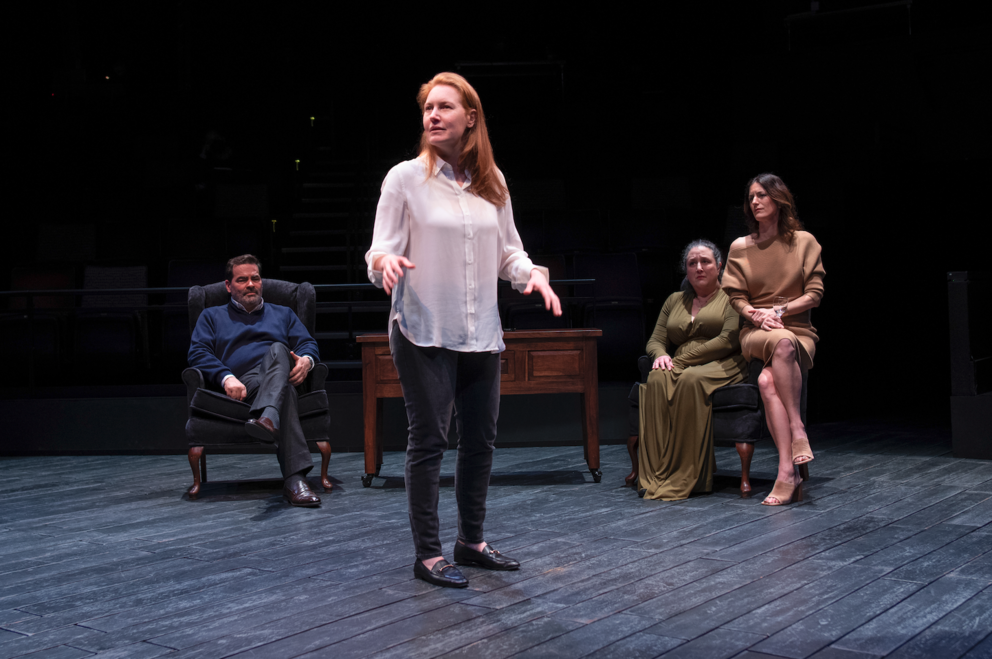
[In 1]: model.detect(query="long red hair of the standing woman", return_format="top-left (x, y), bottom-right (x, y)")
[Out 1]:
top-left (417, 73), bottom-right (510, 208)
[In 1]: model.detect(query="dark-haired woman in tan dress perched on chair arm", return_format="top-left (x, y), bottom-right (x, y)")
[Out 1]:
top-left (723, 174), bottom-right (825, 506)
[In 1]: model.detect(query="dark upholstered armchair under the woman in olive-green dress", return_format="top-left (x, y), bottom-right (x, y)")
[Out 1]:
top-left (627, 358), bottom-right (809, 497)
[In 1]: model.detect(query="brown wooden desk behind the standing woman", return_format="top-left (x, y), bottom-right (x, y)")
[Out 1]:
top-left (357, 329), bottom-right (603, 487)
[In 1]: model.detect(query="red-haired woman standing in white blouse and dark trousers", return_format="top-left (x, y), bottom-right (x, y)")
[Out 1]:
top-left (365, 73), bottom-right (561, 588)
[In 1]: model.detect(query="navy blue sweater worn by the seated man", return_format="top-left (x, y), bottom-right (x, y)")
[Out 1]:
top-left (189, 302), bottom-right (320, 387)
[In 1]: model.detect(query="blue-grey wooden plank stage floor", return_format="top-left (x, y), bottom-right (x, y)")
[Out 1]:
top-left (0, 423), bottom-right (992, 659)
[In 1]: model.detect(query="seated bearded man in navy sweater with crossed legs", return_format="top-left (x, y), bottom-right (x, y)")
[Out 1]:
top-left (189, 254), bottom-right (320, 508)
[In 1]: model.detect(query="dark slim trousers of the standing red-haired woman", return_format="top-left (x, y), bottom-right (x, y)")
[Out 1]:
top-left (389, 326), bottom-right (500, 560)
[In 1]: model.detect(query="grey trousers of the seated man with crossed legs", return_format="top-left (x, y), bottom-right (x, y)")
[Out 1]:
top-left (238, 343), bottom-right (313, 478)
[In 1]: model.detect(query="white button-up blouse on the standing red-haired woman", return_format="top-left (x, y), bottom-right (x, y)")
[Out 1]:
top-left (365, 158), bottom-right (548, 352)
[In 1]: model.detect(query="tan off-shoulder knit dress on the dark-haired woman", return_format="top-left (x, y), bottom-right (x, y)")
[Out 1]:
top-left (723, 231), bottom-right (826, 369)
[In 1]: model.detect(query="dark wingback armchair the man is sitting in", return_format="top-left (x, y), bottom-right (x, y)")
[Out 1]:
top-left (183, 279), bottom-right (331, 499)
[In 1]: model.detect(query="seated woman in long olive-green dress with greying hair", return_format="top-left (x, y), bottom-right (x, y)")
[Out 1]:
top-left (638, 240), bottom-right (747, 501)
